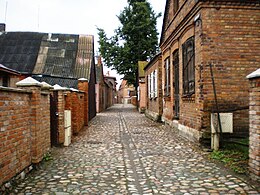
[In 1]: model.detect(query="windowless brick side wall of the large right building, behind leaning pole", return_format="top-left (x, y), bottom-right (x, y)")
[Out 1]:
top-left (198, 5), bottom-right (260, 134)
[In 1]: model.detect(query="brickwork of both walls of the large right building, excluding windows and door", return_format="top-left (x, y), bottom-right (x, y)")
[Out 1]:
top-left (160, 0), bottom-right (260, 138)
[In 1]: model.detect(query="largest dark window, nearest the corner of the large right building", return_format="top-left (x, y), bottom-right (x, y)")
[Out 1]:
top-left (182, 37), bottom-right (195, 95)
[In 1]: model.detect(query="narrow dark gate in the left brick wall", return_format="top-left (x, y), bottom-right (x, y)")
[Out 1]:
top-left (50, 91), bottom-right (59, 146)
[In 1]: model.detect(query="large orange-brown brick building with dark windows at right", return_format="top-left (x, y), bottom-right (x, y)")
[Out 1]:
top-left (160, 0), bottom-right (260, 141)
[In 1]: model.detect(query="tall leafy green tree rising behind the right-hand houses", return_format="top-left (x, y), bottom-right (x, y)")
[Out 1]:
top-left (98, 0), bottom-right (161, 87)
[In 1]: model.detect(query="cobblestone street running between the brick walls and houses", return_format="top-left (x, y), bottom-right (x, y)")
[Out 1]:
top-left (11, 105), bottom-right (260, 195)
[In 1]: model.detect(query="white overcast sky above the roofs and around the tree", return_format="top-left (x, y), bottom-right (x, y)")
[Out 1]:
top-left (0, 0), bottom-right (166, 85)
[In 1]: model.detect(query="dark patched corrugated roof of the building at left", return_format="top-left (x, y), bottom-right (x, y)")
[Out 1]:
top-left (0, 32), bottom-right (95, 87)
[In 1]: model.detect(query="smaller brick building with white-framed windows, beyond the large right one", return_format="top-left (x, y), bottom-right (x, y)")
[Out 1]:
top-left (144, 53), bottom-right (162, 121)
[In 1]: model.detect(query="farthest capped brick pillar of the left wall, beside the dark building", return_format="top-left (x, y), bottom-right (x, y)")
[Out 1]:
top-left (78, 78), bottom-right (89, 126)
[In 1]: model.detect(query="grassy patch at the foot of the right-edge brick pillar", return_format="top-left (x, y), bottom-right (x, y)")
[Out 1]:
top-left (209, 140), bottom-right (249, 174)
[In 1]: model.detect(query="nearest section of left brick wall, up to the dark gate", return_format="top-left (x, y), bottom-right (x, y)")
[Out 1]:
top-left (0, 87), bottom-right (50, 186)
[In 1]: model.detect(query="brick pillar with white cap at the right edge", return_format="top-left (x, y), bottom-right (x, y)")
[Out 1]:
top-left (247, 69), bottom-right (260, 180)
